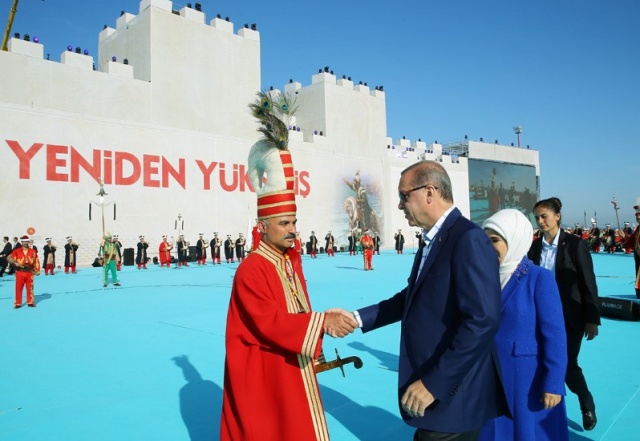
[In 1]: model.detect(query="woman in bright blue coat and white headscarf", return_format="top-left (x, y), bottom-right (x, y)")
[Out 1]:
top-left (480, 209), bottom-right (569, 441)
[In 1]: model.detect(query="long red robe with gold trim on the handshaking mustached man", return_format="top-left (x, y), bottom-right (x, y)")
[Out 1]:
top-left (220, 242), bottom-right (329, 441)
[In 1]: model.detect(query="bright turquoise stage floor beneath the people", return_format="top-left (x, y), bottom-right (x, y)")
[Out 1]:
top-left (0, 249), bottom-right (640, 441)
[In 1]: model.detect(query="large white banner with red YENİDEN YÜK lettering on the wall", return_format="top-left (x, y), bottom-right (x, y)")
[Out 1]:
top-left (0, 107), bottom-right (384, 264)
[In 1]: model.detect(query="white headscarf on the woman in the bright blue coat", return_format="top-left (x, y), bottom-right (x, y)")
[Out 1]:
top-left (482, 208), bottom-right (533, 288)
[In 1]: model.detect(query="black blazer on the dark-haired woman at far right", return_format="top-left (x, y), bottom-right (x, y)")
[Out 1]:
top-left (527, 229), bottom-right (600, 332)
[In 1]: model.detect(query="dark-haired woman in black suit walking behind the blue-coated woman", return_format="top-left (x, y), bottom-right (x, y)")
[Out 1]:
top-left (528, 198), bottom-right (600, 430)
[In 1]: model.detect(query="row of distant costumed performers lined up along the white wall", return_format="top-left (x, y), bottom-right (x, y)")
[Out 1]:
top-left (0, 206), bottom-right (640, 308)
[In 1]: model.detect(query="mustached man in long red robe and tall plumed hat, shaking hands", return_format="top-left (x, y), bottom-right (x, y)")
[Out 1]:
top-left (220, 94), bottom-right (357, 441)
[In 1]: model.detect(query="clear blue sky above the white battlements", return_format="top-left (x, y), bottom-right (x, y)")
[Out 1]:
top-left (5, 0), bottom-right (640, 227)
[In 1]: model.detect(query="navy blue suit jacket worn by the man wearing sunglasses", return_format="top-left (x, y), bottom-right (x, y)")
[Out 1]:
top-left (358, 209), bottom-right (509, 433)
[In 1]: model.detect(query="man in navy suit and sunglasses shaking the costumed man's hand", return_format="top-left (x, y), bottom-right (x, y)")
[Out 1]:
top-left (354, 161), bottom-right (509, 441)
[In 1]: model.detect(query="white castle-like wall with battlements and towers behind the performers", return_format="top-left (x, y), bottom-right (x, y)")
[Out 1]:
top-left (0, 0), bottom-right (537, 264)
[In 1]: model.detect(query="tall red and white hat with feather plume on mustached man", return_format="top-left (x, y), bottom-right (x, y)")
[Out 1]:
top-left (248, 91), bottom-right (297, 219)
